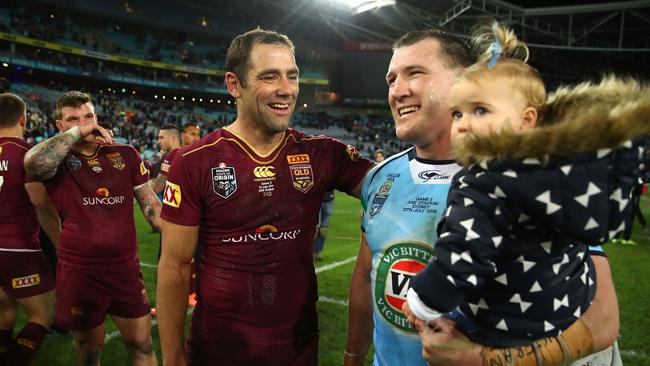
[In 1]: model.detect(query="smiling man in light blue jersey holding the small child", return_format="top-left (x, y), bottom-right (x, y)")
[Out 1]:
top-left (344, 30), bottom-right (618, 366)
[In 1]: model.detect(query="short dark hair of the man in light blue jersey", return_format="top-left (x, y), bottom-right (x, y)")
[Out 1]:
top-left (393, 28), bottom-right (474, 68)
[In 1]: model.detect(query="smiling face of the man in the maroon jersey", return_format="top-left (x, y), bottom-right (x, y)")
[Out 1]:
top-left (227, 44), bottom-right (298, 135)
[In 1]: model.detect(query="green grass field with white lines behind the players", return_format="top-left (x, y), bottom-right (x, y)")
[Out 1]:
top-left (22, 194), bottom-right (650, 366)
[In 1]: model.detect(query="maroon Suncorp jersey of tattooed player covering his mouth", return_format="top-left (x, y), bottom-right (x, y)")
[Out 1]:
top-left (45, 144), bottom-right (149, 265)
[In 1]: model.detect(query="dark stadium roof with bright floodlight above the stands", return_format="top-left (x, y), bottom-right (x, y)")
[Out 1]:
top-left (189, 0), bottom-right (650, 81)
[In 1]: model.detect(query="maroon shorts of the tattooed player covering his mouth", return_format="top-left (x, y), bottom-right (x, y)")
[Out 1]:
top-left (55, 261), bottom-right (151, 331)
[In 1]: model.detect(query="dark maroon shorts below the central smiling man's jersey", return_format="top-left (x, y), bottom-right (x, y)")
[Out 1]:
top-left (186, 303), bottom-right (318, 366)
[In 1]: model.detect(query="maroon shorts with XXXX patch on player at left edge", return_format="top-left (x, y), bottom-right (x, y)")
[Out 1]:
top-left (0, 251), bottom-right (54, 299)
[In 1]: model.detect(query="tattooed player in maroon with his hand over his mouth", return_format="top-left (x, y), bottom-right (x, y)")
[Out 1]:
top-left (25, 91), bottom-right (160, 365)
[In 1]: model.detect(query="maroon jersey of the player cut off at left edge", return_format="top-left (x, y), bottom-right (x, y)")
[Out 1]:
top-left (0, 137), bottom-right (40, 250)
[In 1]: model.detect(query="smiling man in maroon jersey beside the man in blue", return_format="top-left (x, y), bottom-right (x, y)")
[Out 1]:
top-left (157, 29), bottom-right (373, 366)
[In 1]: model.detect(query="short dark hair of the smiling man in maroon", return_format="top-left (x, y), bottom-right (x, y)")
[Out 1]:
top-left (226, 27), bottom-right (295, 86)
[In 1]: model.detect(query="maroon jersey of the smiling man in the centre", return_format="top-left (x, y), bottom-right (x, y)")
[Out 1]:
top-left (162, 129), bottom-right (373, 345)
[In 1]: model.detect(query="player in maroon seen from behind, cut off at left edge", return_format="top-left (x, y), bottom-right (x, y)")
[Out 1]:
top-left (0, 93), bottom-right (60, 366)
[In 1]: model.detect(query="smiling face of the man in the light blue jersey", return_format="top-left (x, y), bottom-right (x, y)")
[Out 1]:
top-left (386, 38), bottom-right (460, 146)
